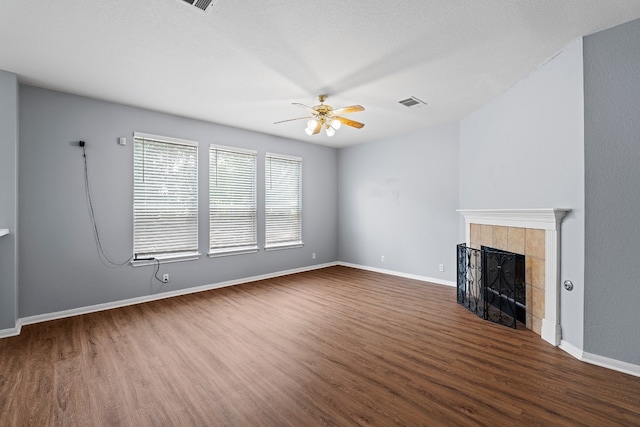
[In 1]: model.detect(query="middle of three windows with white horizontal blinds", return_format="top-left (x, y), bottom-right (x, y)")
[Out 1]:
top-left (209, 145), bottom-right (258, 256)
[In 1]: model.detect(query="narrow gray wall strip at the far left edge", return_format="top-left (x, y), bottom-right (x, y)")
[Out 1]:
top-left (0, 71), bottom-right (18, 331)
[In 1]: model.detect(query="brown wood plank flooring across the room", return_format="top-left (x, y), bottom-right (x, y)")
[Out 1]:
top-left (0, 267), bottom-right (640, 427)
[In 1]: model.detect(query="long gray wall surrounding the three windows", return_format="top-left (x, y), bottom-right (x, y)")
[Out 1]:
top-left (17, 86), bottom-right (338, 317)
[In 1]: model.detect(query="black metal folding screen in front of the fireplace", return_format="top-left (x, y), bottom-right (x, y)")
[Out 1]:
top-left (458, 243), bottom-right (526, 328)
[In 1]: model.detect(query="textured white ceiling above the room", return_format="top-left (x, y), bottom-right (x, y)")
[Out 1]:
top-left (0, 0), bottom-right (640, 147)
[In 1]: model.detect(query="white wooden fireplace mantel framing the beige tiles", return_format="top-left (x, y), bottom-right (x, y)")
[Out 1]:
top-left (458, 208), bottom-right (571, 346)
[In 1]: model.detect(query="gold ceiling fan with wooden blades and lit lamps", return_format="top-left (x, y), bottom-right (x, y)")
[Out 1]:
top-left (274, 95), bottom-right (364, 136)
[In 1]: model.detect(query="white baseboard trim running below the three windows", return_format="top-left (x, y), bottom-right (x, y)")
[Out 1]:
top-left (17, 262), bottom-right (337, 330)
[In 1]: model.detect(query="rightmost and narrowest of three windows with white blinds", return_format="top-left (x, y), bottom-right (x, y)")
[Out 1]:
top-left (265, 153), bottom-right (302, 249)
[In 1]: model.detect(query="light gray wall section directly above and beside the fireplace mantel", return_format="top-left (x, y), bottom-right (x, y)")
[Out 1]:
top-left (460, 40), bottom-right (585, 348)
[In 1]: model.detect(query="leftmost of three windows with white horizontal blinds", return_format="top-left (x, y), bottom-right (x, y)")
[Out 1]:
top-left (133, 132), bottom-right (198, 259)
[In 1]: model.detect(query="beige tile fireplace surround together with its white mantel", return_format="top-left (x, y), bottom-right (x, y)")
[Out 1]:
top-left (458, 208), bottom-right (570, 346)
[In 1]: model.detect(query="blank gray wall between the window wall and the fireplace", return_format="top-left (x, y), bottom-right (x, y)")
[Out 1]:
top-left (338, 123), bottom-right (459, 281)
